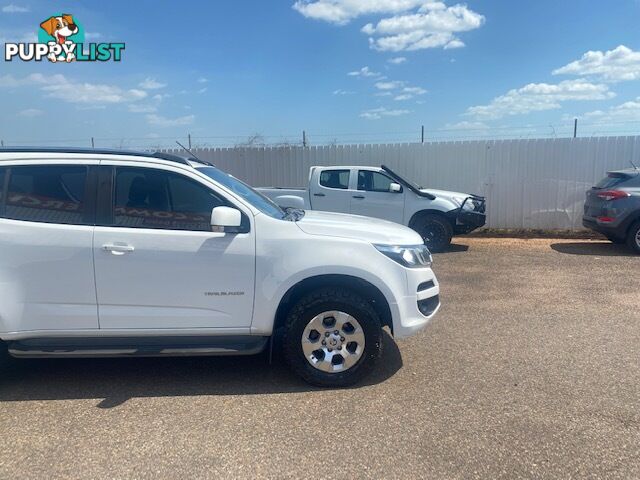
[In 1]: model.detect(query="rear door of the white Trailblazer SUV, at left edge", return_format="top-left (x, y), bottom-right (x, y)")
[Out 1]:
top-left (0, 161), bottom-right (98, 332)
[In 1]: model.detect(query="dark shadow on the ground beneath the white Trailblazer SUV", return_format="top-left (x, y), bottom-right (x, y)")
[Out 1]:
top-left (0, 331), bottom-right (402, 408)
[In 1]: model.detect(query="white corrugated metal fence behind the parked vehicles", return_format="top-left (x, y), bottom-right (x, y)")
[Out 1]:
top-left (164, 136), bottom-right (640, 229)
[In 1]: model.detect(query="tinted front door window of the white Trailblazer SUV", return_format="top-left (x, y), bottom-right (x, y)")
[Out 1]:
top-left (114, 167), bottom-right (227, 232)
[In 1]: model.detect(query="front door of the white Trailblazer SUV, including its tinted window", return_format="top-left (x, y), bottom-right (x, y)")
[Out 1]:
top-left (94, 166), bottom-right (255, 329)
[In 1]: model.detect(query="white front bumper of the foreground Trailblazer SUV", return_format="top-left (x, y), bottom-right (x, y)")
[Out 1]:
top-left (393, 268), bottom-right (440, 338)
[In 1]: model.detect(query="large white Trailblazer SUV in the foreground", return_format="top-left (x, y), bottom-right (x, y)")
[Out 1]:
top-left (0, 148), bottom-right (439, 386)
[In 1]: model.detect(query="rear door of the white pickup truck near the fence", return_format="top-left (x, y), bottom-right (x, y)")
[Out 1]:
top-left (309, 167), bottom-right (353, 213)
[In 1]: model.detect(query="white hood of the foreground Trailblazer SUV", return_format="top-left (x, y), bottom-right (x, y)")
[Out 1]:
top-left (296, 210), bottom-right (423, 245)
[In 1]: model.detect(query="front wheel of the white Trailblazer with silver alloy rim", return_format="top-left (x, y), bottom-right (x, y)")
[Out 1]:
top-left (283, 287), bottom-right (382, 387)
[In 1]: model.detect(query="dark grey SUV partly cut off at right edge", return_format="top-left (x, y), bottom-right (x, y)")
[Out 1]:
top-left (582, 169), bottom-right (640, 254)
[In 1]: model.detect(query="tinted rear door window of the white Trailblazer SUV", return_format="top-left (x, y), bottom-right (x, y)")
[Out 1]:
top-left (3, 165), bottom-right (91, 225)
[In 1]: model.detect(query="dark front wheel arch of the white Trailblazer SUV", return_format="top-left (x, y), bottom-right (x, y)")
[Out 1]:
top-left (273, 274), bottom-right (393, 334)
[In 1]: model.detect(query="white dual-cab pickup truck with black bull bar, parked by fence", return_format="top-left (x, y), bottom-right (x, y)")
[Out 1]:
top-left (257, 165), bottom-right (486, 252)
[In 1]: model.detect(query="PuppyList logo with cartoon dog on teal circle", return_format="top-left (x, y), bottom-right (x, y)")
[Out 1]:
top-left (4, 13), bottom-right (125, 63)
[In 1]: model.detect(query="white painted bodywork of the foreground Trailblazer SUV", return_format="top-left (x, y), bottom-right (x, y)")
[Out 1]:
top-left (0, 153), bottom-right (439, 340)
